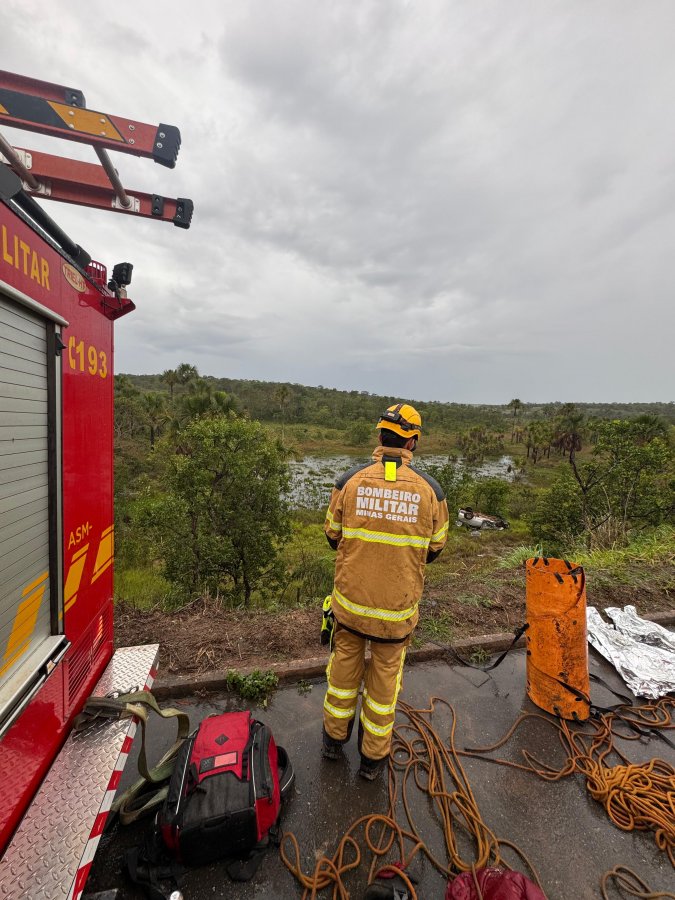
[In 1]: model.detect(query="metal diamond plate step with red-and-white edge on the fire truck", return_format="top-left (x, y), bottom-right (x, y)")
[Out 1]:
top-left (0, 644), bottom-right (159, 900)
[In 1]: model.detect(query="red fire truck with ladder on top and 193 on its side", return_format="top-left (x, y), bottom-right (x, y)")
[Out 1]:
top-left (0, 72), bottom-right (192, 900)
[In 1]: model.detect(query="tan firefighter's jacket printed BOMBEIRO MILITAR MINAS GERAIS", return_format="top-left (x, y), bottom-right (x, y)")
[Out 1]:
top-left (325, 447), bottom-right (448, 641)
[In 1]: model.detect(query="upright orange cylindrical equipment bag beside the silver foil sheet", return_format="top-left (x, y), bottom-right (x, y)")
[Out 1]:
top-left (525, 556), bottom-right (590, 721)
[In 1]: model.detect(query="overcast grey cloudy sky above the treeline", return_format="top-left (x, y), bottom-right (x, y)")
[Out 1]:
top-left (0, 0), bottom-right (675, 403)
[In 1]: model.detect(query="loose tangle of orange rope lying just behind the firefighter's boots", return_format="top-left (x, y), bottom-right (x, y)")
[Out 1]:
top-left (280, 697), bottom-right (543, 900)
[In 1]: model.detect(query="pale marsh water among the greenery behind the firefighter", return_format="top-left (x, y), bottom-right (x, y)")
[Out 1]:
top-left (288, 453), bottom-right (513, 509)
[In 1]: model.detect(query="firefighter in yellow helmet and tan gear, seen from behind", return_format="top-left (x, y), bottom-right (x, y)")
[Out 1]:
top-left (322, 403), bottom-right (448, 781)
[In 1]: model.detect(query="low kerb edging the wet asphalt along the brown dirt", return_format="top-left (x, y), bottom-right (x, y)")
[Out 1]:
top-left (152, 610), bottom-right (675, 700)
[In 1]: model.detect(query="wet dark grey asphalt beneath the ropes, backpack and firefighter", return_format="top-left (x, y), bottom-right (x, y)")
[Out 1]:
top-left (87, 650), bottom-right (675, 900)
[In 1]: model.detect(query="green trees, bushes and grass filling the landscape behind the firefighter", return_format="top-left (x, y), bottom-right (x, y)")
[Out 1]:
top-left (115, 363), bottom-right (675, 620)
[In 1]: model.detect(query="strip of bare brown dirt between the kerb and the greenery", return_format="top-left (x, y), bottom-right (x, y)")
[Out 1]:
top-left (115, 566), bottom-right (675, 675)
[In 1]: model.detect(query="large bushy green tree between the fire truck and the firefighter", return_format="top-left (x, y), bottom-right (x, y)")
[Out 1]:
top-left (137, 416), bottom-right (290, 606)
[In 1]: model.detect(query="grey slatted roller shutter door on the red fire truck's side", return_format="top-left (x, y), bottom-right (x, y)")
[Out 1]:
top-left (0, 291), bottom-right (52, 706)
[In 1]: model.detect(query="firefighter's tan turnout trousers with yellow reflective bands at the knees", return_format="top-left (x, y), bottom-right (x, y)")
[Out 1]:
top-left (323, 622), bottom-right (409, 759)
